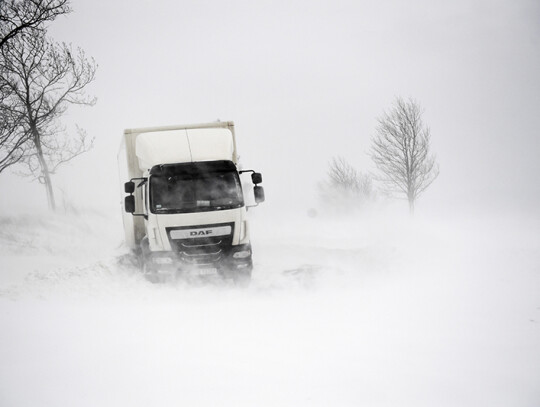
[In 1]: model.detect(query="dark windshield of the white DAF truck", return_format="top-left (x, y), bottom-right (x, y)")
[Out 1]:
top-left (150, 171), bottom-right (244, 213)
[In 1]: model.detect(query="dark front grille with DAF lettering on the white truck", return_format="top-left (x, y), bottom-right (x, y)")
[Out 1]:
top-left (166, 222), bottom-right (234, 267)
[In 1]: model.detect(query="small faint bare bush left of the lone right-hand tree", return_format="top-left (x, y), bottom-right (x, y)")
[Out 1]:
top-left (319, 157), bottom-right (375, 214)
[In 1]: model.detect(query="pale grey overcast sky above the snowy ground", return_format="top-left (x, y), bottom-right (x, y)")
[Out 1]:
top-left (0, 0), bottom-right (540, 217)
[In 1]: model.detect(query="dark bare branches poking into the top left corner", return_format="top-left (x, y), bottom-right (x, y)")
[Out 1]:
top-left (0, 0), bottom-right (71, 48)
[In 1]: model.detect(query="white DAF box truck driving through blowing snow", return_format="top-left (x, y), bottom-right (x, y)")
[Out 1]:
top-left (118, 122), bottom-right (264, 283)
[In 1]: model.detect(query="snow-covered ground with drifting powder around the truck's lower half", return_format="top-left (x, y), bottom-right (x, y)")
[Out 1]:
top-left (0, 210), bottom-right (540, 407)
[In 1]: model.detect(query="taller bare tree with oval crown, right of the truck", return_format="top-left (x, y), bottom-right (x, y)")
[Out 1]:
top-left (371, 98), bottom-right (439, 214)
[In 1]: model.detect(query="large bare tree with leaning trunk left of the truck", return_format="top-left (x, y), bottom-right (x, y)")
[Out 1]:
top-left (0, 30), bottom-right (96, 210)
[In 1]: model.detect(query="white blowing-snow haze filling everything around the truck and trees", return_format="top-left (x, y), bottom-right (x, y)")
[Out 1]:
top-left (0, 0), bottom-right (540, 407)
